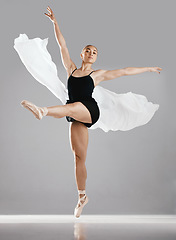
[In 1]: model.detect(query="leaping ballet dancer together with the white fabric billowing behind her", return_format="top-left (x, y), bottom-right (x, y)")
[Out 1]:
top-left (14, 6), bottom-right (162, 217)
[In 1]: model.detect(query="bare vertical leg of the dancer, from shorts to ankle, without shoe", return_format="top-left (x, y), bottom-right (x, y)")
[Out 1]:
top-left (70, 122), bottom-right (88, 206)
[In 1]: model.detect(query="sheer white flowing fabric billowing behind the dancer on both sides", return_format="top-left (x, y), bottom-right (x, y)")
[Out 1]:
top-left (14, 34), bottom-right (159, 132)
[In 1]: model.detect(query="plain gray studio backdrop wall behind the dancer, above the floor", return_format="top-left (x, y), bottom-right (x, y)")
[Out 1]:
top-left (0, 0), bottom-right (176, 215)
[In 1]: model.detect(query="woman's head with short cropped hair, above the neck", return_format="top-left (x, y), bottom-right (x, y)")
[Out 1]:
top-left (80, 46), bottom-right (98, 63)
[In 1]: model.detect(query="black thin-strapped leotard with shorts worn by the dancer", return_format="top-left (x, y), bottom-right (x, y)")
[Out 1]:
top-left (66, 68), bottom-right (100, 128)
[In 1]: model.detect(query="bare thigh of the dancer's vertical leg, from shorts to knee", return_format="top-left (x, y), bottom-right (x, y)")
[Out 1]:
top-left (69, 121), bottom-right (89, 161)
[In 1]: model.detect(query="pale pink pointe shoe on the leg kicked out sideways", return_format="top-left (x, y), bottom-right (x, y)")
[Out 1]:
top-left (21, 100), bottom-right (48, 120)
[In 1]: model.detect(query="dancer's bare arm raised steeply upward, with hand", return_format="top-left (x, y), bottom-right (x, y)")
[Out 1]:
top-left (45, 6), bottom-right (76, 75)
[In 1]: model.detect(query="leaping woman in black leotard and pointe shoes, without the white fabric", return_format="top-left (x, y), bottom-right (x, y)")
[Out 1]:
top-left (16, 7), bottom-right (162, 217)
